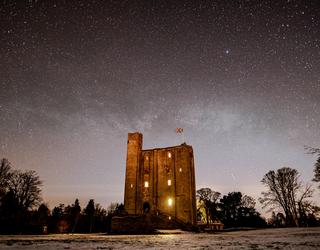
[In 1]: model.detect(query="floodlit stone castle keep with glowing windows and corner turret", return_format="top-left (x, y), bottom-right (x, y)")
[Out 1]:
top-left (119, 133), bottom-right (196, 228)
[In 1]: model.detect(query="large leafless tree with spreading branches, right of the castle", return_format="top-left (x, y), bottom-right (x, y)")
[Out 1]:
top-left (260, 167), bottom-right (312, 226)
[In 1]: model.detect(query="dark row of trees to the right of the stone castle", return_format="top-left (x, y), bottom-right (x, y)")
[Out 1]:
top-left (197, 147), bottom-right (320, 228)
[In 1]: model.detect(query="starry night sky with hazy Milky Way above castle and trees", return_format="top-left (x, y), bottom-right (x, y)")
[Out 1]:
top-left (0, 0), bottom-right (320, 212)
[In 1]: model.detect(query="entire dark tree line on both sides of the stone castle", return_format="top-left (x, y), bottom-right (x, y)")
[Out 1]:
top-left (0, 147), bottom-right (320, 233)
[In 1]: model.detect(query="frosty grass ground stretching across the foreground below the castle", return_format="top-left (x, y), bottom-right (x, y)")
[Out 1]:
top-left (0, 228), bottom-right (320, 250)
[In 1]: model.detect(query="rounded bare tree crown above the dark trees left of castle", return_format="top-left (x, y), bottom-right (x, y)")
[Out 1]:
top-left (9, 170), bottom-right (42, 210)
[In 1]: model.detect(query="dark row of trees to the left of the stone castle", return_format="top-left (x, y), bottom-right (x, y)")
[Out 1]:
top-left (0, 159), bottom-right (124, 234)
